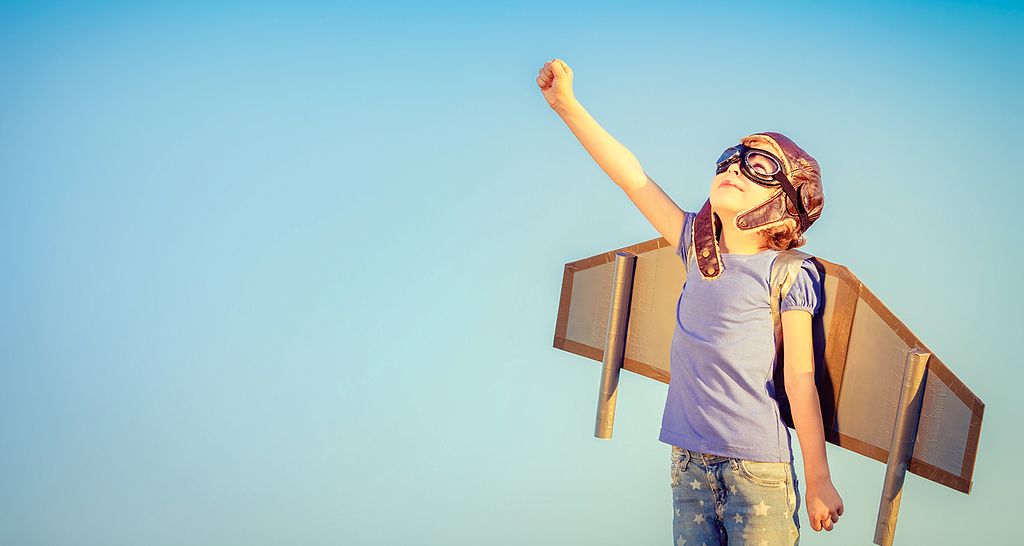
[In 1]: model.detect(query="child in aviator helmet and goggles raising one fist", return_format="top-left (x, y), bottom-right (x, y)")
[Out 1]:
top-left (537, 59), bottom-right (843, 546)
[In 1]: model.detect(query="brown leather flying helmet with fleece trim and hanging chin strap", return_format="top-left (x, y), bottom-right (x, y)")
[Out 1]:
top-left (692, 133), bottom-right (824, 280)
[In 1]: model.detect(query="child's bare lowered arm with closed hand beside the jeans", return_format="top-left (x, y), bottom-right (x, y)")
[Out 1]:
top-left (782, 309), bottom-right (843, 531)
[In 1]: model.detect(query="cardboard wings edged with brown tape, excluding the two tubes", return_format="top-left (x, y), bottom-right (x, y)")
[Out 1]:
top-left (554, 239), bottom-right (985, 493)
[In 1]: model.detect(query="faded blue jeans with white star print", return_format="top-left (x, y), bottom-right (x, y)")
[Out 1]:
top-left (672, 447), bottom-right (800, 546)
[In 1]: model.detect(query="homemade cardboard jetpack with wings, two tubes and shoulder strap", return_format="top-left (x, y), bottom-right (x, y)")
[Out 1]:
top-left (554, 239), bottom-right (985, 546)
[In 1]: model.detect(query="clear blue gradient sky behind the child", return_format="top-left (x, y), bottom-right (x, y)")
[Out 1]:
top-left (0, 1), bottom-right (1024, 546)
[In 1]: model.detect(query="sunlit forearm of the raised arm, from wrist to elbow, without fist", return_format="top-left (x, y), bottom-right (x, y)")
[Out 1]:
top-left (555, 98), bottom-right (647, 194)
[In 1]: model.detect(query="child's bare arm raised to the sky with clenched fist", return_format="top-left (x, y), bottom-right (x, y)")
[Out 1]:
top-left (537, 58), bottom-right (684, 246)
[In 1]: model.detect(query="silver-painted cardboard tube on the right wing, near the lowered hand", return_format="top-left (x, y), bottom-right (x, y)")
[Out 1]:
top-left (874, 349), bottom-right (932, 546)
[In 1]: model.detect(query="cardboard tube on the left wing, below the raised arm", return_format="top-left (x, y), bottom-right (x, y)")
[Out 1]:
top-left (594, 252), bottom-right (637, 439)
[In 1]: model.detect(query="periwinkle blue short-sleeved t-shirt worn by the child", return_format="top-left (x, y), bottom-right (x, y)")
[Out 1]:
top-left (660, 213), bottom-right (821, 462)
